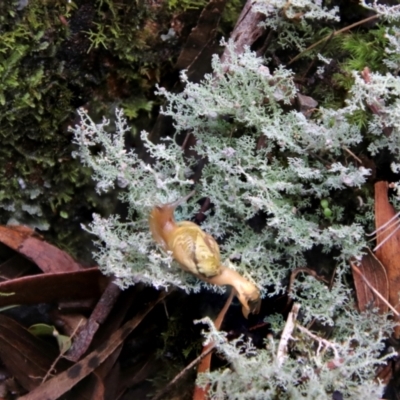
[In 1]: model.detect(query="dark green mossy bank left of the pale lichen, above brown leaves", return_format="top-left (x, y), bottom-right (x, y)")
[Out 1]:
top-left (0, 0), bottom-right (179, 255)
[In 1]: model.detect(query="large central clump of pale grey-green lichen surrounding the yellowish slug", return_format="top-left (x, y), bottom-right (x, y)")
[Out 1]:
top-left (69, 39), bottom-right (369, 294)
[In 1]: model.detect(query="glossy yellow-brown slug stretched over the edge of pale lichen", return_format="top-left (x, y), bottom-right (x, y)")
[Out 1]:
top-left (149, 191), bottom-right (261, 318)
